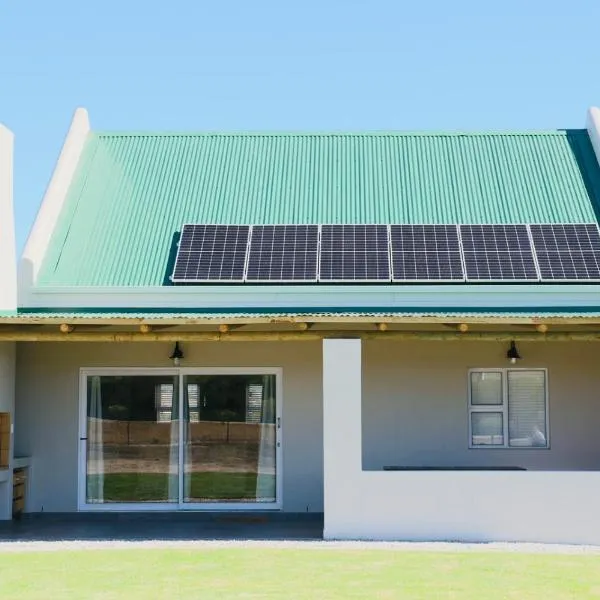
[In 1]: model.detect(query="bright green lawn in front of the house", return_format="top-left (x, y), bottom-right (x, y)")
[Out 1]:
top-left (0, 548), bottom-right (600, 600)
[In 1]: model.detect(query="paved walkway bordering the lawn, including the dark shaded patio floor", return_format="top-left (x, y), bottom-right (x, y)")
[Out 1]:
top-left (0, 513), bottom-right (600, 556)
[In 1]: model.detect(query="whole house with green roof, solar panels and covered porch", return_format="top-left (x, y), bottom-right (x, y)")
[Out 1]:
top-left (0, 108), bottom-right (600, 544)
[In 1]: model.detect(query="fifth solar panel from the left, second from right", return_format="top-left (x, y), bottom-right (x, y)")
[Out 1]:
top-left (460, 225), bottom-right (539, 281)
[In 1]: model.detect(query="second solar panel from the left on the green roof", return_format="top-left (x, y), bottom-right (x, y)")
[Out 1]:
top-left (246, 225), bottom-right (319, 282)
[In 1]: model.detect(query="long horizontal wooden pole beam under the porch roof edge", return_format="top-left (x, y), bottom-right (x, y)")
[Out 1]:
top-left (0, 329), bottom-right (600, 343)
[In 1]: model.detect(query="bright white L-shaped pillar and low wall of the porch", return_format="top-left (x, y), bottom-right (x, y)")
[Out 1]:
top-left (323, 340), bottom-right (600, 544)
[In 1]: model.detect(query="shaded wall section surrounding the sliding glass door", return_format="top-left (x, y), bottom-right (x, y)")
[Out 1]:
top-left (15, 343), bottom-right (323, 512)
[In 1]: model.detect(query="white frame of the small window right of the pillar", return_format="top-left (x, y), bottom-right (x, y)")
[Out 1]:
top-left (467, 367), bottom-right (550, 450)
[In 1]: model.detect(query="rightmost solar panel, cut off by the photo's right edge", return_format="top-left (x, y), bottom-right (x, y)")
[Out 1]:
top-left (529, 223), bottom-right (600, 281)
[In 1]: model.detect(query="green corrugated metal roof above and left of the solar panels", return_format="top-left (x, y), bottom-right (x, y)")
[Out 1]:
top-left (38, 130), bottom-right (600, 286)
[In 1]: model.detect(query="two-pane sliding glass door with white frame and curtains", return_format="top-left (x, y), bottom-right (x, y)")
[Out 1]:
top-left (80, 369), bottom-right (281, 510)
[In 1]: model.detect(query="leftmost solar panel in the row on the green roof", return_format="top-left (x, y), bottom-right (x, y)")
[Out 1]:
top-left (171, 225), bottom-right (250, 283)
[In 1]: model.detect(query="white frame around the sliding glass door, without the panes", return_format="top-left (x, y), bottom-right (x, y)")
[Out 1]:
top-left (77, 367), bottom-right (283, 512)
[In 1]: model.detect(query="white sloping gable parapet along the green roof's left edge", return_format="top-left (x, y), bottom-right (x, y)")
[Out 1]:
top-left (19, 108), bottom-right (90, 299)
